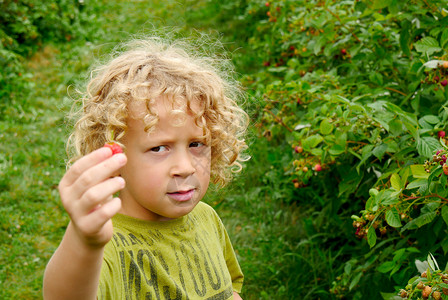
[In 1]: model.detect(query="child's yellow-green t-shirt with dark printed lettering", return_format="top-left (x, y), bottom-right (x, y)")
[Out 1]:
top-left (98, 202), bottom-right (243, 300)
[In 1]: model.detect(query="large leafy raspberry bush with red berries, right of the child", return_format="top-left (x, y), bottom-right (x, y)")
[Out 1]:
top-left (191, 0), bottom-right (448, 299)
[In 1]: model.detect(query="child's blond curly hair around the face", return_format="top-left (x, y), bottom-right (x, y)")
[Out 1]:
top-left (68, 37), bottom-right (248, 185)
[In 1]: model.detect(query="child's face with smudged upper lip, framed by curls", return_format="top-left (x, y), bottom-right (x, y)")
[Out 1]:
top-left (120, 97), bottom-right (211, 221)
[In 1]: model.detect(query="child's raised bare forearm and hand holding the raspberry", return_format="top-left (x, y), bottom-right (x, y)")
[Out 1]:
top-left (43, 148), bottom-right (126, 300)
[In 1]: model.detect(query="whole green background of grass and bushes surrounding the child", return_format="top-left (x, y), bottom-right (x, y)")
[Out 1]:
top-left (0, 0), bottom-right (448, 299)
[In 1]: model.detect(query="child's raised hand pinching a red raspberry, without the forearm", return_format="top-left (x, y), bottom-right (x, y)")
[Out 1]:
top-left (59, 147), bottom-right (126, 248)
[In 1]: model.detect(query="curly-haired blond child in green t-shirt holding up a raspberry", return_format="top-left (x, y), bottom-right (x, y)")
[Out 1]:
top-left (43, 39), bottom-right (247, 300)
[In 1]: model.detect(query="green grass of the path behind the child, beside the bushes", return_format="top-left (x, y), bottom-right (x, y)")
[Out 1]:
top-left (0, 0), bottom-right (344, 299)
